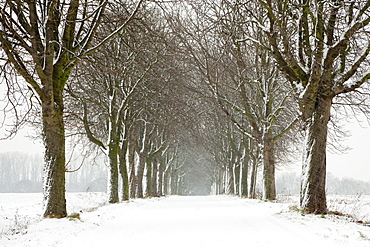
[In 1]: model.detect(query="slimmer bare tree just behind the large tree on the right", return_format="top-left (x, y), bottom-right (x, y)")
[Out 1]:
top-left (162, 1), bottom-right (298, 200)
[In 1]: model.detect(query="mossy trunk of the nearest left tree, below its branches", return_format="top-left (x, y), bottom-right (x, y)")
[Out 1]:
top-left (42, 96), bottom-right (67, 218)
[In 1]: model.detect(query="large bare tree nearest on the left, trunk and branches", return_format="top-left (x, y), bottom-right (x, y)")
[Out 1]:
top-left (0, 0), bottom-right (142, 218)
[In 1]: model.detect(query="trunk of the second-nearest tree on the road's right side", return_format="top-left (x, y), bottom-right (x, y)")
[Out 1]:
top-left (263, 132), bottom-right (276, 200)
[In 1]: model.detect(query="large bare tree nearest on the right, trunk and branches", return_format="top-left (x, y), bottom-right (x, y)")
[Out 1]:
top-left (254, 0), bottom-right (370, 213)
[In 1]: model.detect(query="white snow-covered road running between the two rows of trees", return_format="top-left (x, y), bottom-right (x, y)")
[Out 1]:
top-left (0, 196), bottom-right (370, 247)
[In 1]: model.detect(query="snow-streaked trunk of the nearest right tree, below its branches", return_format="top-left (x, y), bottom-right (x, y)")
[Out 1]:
top-left (300, 97), bottom-right (332, 214)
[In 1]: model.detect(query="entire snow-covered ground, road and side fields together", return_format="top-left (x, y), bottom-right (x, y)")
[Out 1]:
top-left (0, 193), bottom-right (370, 247)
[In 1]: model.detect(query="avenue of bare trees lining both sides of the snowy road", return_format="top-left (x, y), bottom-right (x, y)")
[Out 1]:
top-left (0, 0), bottom-right (370, 217)
